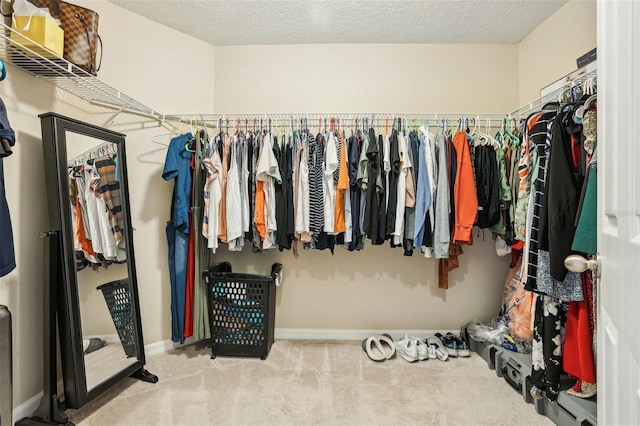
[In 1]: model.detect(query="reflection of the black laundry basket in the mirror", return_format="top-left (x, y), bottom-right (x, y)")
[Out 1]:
top-left (97, 278), bottom-right (136, 357)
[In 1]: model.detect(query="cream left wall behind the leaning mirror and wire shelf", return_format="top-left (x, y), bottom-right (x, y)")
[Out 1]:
top-left (0, 0), bottom-right (215, 412)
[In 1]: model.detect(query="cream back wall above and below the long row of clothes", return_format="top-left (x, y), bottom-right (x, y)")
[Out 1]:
top-left (215, 45), bottom-right (518, 330)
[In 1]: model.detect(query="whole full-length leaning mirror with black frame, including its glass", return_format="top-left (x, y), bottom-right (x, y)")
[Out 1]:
top-left (41, 113), bottom-right (157, 408)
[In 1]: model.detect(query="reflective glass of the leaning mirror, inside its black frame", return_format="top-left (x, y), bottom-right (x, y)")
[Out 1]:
top-left (65, 130), bottom-right (137, 391)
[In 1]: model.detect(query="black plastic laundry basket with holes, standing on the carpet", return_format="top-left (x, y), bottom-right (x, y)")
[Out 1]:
top-left (203, 262), bottom-right (282, 359)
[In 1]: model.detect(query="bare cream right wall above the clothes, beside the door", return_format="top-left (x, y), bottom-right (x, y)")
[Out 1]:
top-left (512, 0), bottom-right (596, 106)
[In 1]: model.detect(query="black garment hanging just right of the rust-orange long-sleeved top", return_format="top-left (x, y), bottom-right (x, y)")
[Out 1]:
top-left (474, 146), bottom-right (500, 229)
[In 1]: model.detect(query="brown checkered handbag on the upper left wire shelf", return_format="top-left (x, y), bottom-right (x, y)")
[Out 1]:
top-left (29, 0), bottom-right (102, 75)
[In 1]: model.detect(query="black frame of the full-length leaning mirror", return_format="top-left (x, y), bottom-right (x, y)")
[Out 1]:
top-left (39, 112), bottom-right (149, 408)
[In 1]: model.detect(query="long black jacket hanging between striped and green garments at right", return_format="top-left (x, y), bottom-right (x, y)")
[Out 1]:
top-left (539, 110), bottom-right (584, 281)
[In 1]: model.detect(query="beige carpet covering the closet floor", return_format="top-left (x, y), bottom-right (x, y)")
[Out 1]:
top-left (67, 340), bottom-right (553, 426)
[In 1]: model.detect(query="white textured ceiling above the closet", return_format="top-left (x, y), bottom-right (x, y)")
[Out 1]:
top-left (109, 0), bottom-right (566, 45)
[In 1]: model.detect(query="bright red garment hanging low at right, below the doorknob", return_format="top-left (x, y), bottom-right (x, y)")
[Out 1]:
top-left (562, 272), bottom-right (596, 383)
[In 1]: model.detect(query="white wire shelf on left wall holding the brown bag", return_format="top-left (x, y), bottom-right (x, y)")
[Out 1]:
top-left (0, 22), bottom-right (161, 119)
